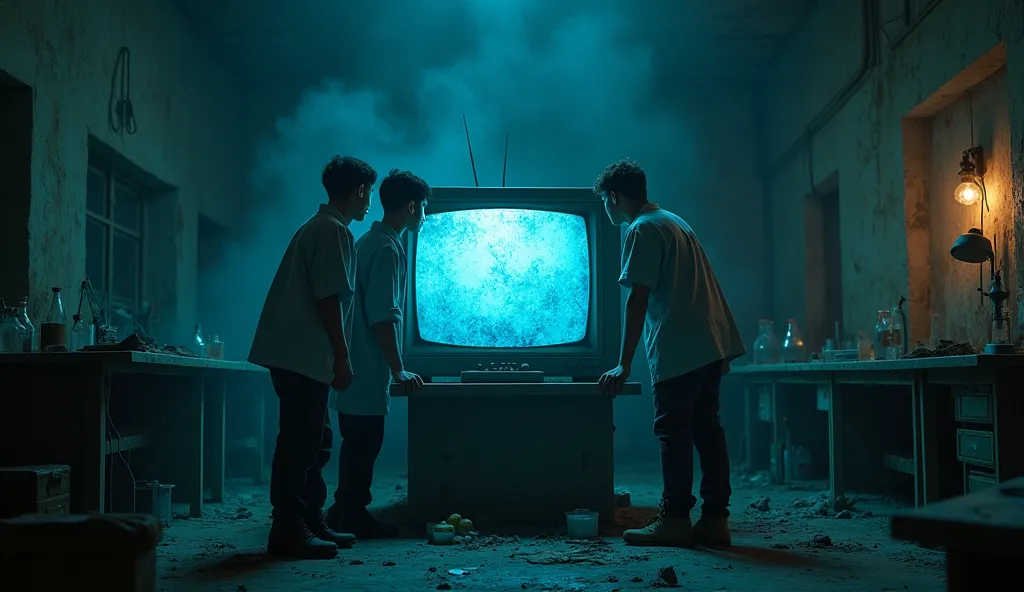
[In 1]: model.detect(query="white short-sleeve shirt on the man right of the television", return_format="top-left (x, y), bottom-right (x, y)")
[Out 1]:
top-left (618, 204), bottom-right (746, 383)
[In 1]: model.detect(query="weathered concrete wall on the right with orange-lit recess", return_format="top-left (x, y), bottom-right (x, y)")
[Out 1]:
top-left (763, 0), bottom-right (1024, 350)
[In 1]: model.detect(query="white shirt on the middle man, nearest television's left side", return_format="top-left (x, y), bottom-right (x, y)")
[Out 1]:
top-left (329, 222), bottom-right (408, 416)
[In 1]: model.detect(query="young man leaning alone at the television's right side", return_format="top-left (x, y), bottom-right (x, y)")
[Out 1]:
top-left (594, 159), bottom-right (745, 547)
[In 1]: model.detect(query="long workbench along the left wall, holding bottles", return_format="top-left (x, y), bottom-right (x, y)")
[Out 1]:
top-left (0, 351), bottom-right (269, 517)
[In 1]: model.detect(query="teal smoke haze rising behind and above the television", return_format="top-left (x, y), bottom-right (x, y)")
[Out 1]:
top-left (210, 0), bottom-right (692, 350)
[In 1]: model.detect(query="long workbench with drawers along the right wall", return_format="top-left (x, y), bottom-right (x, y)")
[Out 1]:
top-left (731, 355), bottom-right (1024, 506)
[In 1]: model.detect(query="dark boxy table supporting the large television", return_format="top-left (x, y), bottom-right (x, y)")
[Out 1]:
top-left (391, 382), bottom-right (640, 530)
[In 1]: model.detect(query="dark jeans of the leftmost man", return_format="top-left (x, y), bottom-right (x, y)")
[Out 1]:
top-left (270, 369), bottom-right (334, 519)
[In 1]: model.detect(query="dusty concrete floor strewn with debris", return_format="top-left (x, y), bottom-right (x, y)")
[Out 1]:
top-left (158, 464), bottom-right (944, 592)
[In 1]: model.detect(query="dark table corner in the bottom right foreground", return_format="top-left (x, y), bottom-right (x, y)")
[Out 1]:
top-left (892, 478), bottom-right (1024, 592)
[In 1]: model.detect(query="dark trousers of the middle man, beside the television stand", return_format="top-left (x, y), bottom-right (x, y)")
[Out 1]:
top-left (334, 413), bottom-right (384, 514)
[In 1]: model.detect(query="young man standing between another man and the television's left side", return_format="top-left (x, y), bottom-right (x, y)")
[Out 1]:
top-left (328, 169), bottom-right (430, 539)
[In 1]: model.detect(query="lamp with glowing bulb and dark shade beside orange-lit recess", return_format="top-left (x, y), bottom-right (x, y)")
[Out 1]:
top-left (949, 147), bottom-right (1017, 354)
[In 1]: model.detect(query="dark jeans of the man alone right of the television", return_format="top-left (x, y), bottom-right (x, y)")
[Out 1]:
top-left (654, 362), bottom-right (732, 516)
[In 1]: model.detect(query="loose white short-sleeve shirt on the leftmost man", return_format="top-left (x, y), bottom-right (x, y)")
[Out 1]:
top-left (249, 204), bottom-right (355, 384)
